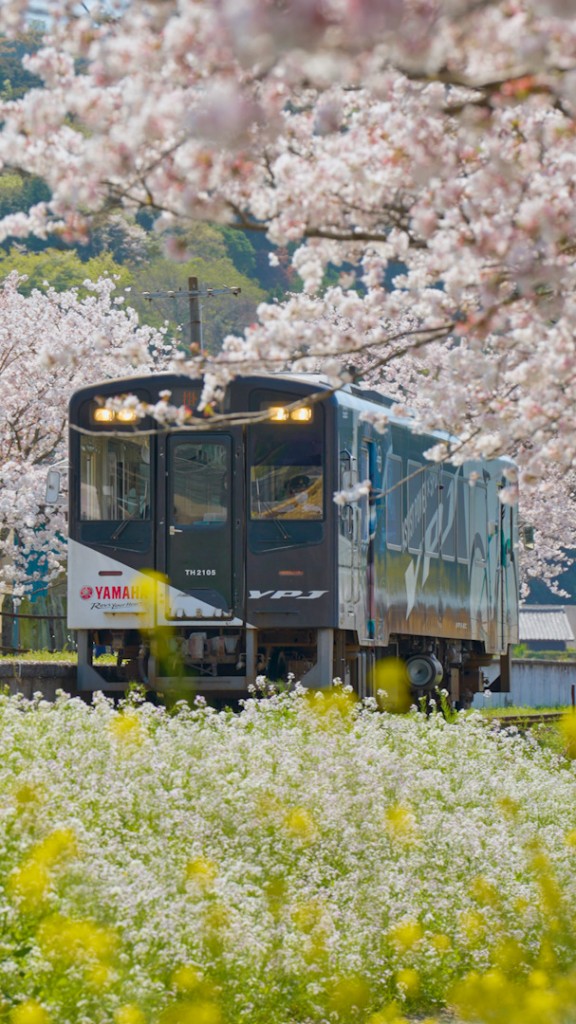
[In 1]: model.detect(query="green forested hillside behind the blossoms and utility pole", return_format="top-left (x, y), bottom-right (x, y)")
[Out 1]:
top-left (0, 28), bottom-right (298, 352)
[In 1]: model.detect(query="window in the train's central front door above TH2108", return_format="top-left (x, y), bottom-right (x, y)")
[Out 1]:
top-left (171, 439), bottom-right (229, 526)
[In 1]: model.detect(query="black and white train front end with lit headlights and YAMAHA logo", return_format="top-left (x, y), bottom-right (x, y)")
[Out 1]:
top-left (68, 375), bottom-right (336, 698)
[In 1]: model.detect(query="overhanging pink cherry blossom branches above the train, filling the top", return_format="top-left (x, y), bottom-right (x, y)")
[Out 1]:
top-left (0, 0), bottom-right (576, 589)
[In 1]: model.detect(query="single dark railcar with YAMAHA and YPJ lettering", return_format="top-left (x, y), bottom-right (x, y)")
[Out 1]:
top-left (68, 373), bottom-right (519, 705)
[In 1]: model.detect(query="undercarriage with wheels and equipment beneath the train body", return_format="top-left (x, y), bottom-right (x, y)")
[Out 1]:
top-left (77, 626), bottom-right (508, 707)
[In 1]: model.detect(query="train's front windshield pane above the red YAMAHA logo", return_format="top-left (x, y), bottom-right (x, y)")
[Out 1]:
top-left (80, 435), bottom-right (150, 522)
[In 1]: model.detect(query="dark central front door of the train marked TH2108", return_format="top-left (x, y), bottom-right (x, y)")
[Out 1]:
top-left (165, 431), bottom-right (242, 620)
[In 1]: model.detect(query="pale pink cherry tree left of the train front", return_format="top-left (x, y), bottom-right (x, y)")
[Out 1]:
top-left (0, 273), bottom-right (171, 598)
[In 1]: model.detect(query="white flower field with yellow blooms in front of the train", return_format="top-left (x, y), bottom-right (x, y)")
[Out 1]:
top-left (0, 690), bottom-right (576, 1024)
